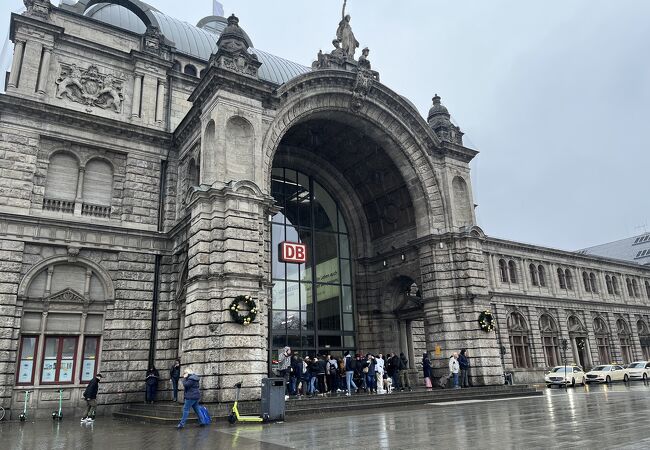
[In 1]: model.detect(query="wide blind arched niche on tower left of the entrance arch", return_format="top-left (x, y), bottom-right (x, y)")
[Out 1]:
top-left (224, 116), bottom-right (255, 181)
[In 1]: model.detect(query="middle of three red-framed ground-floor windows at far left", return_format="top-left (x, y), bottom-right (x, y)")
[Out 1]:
top-left (41, 336), bottom-right (77, 384)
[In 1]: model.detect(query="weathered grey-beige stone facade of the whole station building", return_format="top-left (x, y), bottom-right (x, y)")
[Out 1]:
top-left (0, 0), bottom-right (650, 414)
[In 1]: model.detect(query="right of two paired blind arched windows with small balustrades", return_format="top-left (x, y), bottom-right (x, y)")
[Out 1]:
top-left (81, 159), bottom-right (113, 217)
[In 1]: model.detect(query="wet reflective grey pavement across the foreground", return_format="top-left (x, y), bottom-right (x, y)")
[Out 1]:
top-left (0, 382), bottom-right (650, 450)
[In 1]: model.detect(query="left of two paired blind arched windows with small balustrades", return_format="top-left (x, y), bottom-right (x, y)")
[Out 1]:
top-left (43, 153), bottom-right (79, 213)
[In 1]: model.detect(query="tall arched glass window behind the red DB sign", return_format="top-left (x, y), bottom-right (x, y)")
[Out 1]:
top-left (271, 168), bottom-right (356, 357)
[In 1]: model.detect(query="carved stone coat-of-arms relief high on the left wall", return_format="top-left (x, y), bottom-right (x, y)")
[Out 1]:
top-left (56, 64), bottom-right (124, 113)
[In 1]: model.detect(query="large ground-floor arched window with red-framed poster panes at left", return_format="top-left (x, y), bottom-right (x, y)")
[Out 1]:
top-left (16, 257), bottom-right (113, 386)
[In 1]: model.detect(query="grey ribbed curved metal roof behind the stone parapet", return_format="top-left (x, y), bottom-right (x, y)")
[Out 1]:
top-left (77, 0), bottom-right (310, 84)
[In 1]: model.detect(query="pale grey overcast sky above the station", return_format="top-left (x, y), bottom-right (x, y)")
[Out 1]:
top-left (0, 0), bottom-right (650, 250)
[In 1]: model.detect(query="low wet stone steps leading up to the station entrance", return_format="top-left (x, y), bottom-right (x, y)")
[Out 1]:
top-left (113, 385), bottom-right (542, 425)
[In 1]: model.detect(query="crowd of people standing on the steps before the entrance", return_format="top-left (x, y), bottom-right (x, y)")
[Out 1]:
top-left (278, 347), bottom-right (469, 397)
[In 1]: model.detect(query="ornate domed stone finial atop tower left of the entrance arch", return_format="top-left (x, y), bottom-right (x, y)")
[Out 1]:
top-left (210, 14), bottom-right (262, 78)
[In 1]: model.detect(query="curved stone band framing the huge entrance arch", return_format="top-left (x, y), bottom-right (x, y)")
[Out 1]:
top-left (263, 70), bottom-right (449, 236)
